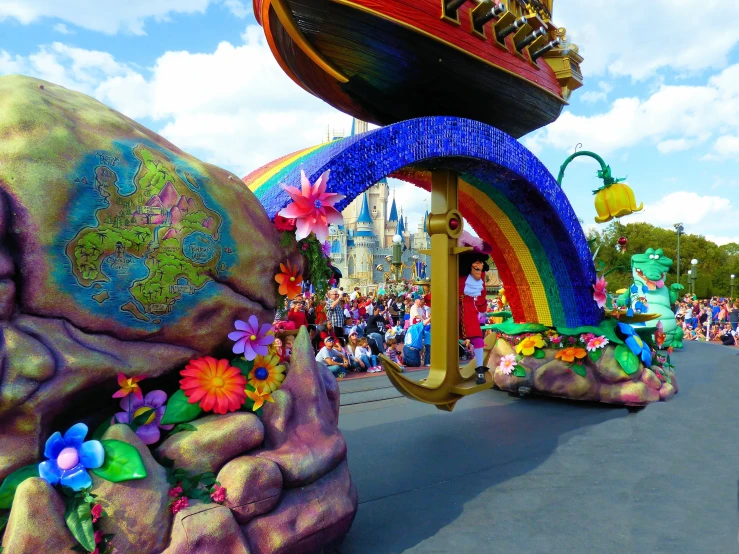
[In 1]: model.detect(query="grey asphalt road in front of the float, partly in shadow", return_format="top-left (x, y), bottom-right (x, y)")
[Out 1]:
top-left (338, 342), bottom-right (739, 554)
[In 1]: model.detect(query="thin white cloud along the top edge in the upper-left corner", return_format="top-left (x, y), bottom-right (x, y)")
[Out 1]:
top-left (0, 0), bottom-right (251, 35)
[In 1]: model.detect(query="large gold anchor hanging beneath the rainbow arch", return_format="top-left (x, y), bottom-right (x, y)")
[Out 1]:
top-left (378, 169), bottom-right (498, 412)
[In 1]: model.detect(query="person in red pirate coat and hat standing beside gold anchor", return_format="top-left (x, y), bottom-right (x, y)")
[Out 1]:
top-left (459, 235), bottom-right (490, 385)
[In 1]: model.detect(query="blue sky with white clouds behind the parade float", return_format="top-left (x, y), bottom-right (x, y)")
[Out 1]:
top-left (0, 0), bottom-right (739, 244)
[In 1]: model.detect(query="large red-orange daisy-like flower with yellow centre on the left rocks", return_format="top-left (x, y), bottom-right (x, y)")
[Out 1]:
top-left (180, 356), bottom-right (246, 414)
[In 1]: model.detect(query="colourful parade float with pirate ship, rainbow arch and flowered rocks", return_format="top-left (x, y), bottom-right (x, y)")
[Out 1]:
top-left (0, 0), bottom-right (677, 554)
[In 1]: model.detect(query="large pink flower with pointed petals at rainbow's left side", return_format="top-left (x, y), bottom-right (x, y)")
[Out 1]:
top-left (277, 170), bottom-right (344, 242)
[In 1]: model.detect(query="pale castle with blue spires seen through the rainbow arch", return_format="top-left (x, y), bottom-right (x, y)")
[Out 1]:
top-left (328, 119), bottom-right (431, 291)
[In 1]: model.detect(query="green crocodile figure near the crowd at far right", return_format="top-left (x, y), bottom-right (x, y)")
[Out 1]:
top-left (618, 248), bottom-right (685, 348)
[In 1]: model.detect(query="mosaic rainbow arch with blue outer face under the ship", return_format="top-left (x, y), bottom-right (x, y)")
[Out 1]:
top-left (244, 117), bottom-right (603, 327)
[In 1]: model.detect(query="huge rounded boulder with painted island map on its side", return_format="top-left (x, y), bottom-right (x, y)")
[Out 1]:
top-left (0, 75), bottom-right (294, 479)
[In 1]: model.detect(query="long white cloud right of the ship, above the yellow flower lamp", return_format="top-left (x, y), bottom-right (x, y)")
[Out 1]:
top-left (524, 64), bottom-right (739, 154)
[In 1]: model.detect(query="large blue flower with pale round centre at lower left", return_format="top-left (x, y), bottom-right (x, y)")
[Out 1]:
top-left (38, 423), bottom-right (105, 491)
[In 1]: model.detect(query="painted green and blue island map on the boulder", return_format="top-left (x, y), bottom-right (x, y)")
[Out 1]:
top-left (66, 144), bottom-right (228, 324)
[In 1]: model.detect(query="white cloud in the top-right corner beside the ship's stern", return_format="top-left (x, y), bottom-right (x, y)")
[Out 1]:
top-left (554, 0), bottom-right (739, 80)
